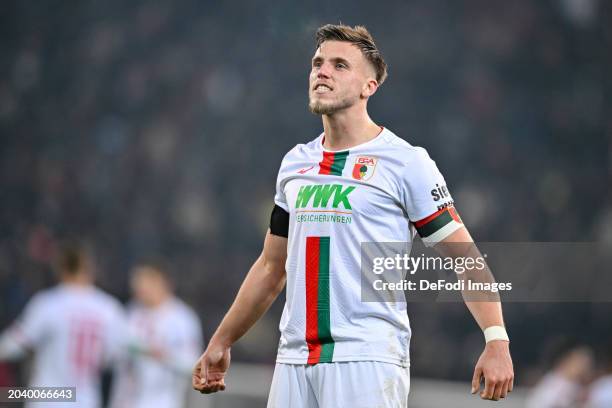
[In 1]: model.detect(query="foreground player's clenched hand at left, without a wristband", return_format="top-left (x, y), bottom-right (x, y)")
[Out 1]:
top-left (192, 342), bottom-right (230, 394)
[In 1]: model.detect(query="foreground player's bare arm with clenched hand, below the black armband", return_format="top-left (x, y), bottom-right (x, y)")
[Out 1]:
top-left (192, 231), bottom-right (287, 394)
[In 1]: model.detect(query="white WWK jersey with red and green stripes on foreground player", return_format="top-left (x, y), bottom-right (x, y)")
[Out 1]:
top-left (274, 129), bottom-right (461, 366)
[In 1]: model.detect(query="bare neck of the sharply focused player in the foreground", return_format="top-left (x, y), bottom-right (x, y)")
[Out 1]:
top-left (323, 104), bottom-right (380, 150)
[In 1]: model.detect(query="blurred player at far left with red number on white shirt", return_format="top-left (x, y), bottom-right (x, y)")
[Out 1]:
top-left (0, 245), bottom-right (125, 408)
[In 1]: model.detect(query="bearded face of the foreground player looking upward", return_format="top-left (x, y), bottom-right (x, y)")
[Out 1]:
top-left (308, 41), bottom-right (375, 115)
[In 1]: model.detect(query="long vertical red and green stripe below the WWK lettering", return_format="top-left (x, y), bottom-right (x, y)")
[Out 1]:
top-left (306, 237), bottom-right (334, 364)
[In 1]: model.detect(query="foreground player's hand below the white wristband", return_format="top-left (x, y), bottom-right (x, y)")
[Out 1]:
top-left (472, 340), bottom-right (514, 401)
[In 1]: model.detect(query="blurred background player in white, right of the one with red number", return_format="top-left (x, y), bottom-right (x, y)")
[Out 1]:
top-left (111, 262), bottom-right (202, 408)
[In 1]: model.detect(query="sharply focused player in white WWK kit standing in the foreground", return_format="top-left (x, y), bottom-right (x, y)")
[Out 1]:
top-left (193, 25), bottom-right (514, 408)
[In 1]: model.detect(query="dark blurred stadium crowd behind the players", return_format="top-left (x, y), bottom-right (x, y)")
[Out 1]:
top-left (0, 0), bottom-right (612, 402)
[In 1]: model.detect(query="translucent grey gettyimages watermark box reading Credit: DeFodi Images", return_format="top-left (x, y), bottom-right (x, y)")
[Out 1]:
top-left (361, 242), bottom-right (612, 302)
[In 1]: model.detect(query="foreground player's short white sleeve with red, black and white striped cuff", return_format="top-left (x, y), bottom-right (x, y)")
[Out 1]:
top-left (401, 148), bottom-right (463, 246)
